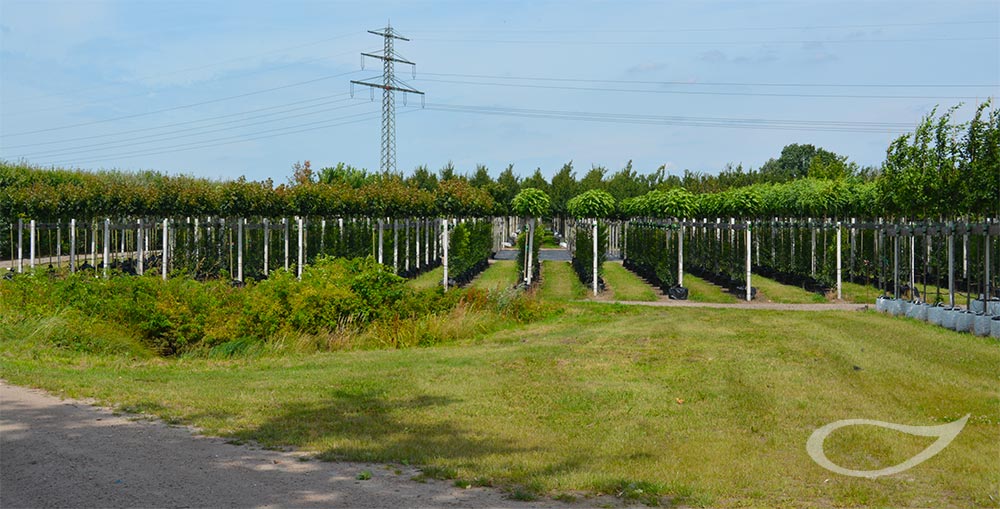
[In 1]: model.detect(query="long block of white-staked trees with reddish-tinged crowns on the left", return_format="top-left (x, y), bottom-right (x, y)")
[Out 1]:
top-left (0, 166), bottom-right (511, 283)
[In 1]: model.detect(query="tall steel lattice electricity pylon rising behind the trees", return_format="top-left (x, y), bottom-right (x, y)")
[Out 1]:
top-left (351, 23), bottom-right (424, 173)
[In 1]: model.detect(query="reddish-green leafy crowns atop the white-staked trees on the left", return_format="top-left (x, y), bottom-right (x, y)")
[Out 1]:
top-left (0, 162), bottom-right (494, 221)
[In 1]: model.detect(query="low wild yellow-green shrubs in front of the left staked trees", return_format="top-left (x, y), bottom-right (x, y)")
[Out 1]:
top-left (0, 258), bottom-right (408, 355)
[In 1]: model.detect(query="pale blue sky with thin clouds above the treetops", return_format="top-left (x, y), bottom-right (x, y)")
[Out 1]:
top-left (0, 0), bottom-right (1000, 182)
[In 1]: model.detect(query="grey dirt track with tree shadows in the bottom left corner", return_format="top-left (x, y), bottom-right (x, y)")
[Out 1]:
top-left (0, 381), bottom-right (580, 508)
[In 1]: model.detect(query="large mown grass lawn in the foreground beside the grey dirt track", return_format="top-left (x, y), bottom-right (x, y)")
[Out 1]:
top-left (0, 304), bottom-right (1000, 507)
